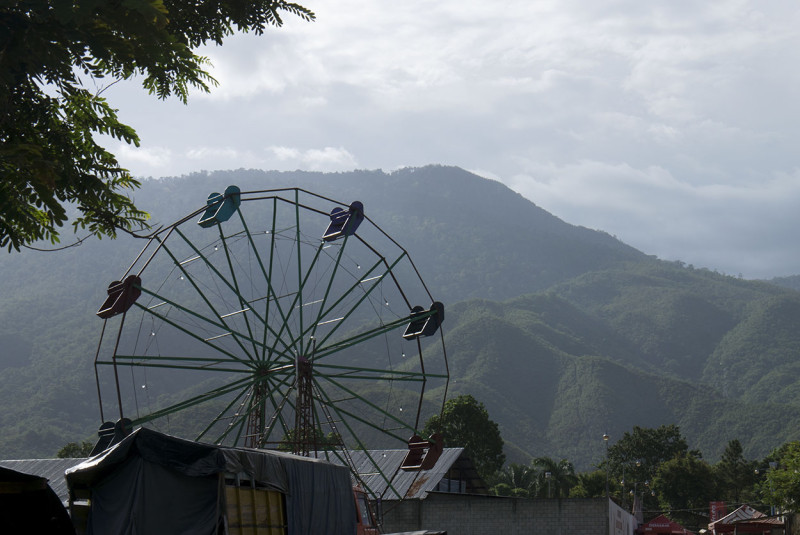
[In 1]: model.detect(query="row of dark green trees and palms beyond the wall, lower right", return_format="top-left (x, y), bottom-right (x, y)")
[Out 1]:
top-left (488, 425), bottom-right (800, 531)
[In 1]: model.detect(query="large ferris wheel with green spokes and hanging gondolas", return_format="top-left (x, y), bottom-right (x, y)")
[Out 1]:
top-left (95, 186), bottom-right (449, 498)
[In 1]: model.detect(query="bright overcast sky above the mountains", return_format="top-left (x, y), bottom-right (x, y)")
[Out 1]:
top-left (107, 0), bottom-right (800, 278)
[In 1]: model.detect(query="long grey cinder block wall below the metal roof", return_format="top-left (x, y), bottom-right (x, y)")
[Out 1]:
top-left (383, 492), bottom-right (608, 535)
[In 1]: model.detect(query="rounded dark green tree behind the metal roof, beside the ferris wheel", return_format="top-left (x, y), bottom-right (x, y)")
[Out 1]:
top-left (424, 394), bottom-right (506, 479)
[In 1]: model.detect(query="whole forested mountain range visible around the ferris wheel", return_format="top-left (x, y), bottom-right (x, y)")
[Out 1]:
top-left (0, 166), bottom-right (800, 467)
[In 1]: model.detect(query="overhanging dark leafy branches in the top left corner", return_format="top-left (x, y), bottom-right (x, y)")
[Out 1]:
top-left (0, 0), bottom-right (314, 251)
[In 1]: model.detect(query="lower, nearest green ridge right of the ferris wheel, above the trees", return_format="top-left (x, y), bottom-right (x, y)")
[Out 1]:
top-left (440, 294), bottom-right (800, 466)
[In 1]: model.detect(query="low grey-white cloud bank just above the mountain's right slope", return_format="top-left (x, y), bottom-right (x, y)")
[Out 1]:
top-left (507, 161), bottom-right (800, 277)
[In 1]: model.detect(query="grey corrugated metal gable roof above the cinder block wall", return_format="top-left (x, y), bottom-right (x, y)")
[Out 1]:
top-left (316, 448), bottom-right (486, 500)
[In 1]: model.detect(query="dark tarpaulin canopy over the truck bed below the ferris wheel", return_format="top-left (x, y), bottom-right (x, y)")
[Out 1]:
top-left (66, 428), bottom-right (356, 535)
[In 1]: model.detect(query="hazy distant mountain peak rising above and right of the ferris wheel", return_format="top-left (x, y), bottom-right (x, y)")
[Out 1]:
top-left (122, 166), bottom-right (647, 302)
